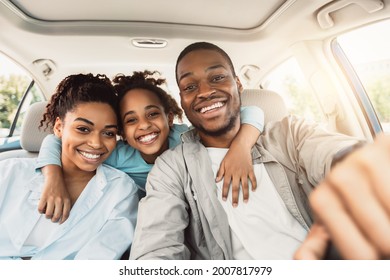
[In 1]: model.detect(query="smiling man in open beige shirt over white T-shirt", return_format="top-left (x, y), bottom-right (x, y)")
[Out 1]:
top-left (130, 42), bottom-right (384, 259)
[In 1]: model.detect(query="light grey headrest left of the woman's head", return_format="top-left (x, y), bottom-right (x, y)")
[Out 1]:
top-left (20, 101), bottom-right (50, 152)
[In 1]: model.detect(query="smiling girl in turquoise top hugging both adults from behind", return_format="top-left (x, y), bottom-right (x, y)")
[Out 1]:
top-left (38, 71), bottom-right (263, 222)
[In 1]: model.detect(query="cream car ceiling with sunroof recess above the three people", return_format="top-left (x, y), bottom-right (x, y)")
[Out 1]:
top-left (0, 0), bottom-right (390, 97)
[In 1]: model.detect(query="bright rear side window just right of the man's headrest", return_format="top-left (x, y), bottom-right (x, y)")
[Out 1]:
top-left (261, 58), bottom-right (322, 122)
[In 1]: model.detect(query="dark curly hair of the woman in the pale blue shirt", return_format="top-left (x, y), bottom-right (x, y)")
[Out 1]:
top-left (39, 73), bottom-right (119, 132)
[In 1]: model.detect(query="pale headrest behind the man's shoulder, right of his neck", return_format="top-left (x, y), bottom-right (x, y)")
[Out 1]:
top-left (241, 89), bottom-right (288, 124)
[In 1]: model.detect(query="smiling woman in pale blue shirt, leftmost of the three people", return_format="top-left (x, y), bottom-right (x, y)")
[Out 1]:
top-left (0, 74), bottom-right (138, 259)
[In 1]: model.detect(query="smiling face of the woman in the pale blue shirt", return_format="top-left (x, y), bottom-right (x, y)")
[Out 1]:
top-left (54, 102), bottom-right (118, 172)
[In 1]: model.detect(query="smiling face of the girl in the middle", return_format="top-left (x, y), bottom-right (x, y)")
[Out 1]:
top-left (120, 89), bottom-right (173, 163)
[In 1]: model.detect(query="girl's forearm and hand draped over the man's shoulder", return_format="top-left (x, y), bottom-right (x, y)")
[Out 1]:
top-left (216, 106), bottom-right (264, 206)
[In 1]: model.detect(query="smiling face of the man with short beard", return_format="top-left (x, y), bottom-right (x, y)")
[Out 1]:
top-left (177, 49), bottom-right (242, 139)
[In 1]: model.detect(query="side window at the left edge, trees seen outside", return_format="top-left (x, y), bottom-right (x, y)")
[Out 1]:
top-left (0, 53), bottom-right (45, 152)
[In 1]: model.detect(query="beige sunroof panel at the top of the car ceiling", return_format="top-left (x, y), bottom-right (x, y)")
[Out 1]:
top-left (11, 0), bottom-right (295, 29)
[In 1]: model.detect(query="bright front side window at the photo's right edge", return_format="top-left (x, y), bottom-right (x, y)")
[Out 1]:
top-left (334, 20), bottom-right (390, 133)
